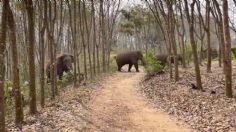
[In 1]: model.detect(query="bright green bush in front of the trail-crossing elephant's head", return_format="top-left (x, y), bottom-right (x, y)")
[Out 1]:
top-left (145, 52), bottom-right (163, 75)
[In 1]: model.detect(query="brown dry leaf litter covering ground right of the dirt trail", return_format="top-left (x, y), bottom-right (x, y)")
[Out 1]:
top-left (140, 62), bottom-right (236, 132)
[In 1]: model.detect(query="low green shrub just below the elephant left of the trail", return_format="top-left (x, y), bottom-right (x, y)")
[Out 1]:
top-left (57, 71), bottom-right (73, 88)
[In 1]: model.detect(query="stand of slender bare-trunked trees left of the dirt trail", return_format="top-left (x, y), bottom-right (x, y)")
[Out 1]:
top-left (0, 0), bottom-right (120, 131)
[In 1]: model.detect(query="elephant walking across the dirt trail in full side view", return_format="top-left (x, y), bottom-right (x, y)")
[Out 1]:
top-left (115, 51), bottom-right (145, 72)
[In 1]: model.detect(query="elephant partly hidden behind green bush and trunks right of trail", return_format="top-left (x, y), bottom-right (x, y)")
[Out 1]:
top-left (155, 54), bottom-right (183, 66)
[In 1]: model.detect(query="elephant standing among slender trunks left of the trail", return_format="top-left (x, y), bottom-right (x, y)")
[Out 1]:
top-left (46, 54), bottom-right (74, 82)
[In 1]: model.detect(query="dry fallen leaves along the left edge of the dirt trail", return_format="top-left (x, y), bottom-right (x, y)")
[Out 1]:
top-left (8, 83), bottom-right (100, 132)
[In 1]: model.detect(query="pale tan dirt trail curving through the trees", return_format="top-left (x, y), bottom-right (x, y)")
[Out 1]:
top-left (89, 67), bottom-right (191, 132)
